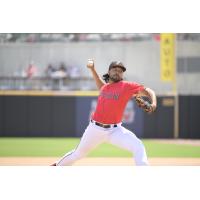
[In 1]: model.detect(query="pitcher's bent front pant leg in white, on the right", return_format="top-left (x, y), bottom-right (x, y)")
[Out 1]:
top-left (108, 126), bottom-right (148, 165)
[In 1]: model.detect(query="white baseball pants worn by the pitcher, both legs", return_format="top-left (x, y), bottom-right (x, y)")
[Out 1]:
top-left (56, 122), bottom-right (148, 166)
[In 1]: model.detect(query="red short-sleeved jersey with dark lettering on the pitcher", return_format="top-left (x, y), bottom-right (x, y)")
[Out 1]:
top-left (92, 81), bottom-right (144, 124)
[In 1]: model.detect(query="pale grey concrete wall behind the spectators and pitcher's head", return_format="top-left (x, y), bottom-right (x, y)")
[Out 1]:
top-left (0, 41), bottom-right (200, 94)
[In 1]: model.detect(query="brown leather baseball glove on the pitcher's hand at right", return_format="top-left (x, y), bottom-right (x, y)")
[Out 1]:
top-left (135, 96), bottom-right (154, 113)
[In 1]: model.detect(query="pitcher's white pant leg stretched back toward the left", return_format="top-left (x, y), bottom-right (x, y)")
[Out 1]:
top-left (56, 123), bottom-right (105, 166)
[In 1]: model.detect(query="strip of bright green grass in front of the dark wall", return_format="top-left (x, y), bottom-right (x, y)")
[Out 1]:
top-left (0, 138), bottom-right (200, 158)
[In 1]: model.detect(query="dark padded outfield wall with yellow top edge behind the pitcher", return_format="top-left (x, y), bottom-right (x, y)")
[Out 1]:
top-left (0, 91), bottom-right (200, 138)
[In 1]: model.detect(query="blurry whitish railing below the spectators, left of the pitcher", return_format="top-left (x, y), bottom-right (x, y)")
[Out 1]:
top-left (0, 76), bottom-right (96, 90)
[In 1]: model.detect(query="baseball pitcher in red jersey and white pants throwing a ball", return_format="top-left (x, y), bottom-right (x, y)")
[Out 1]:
top-left (52, 59), bottom-right (157, 166)
